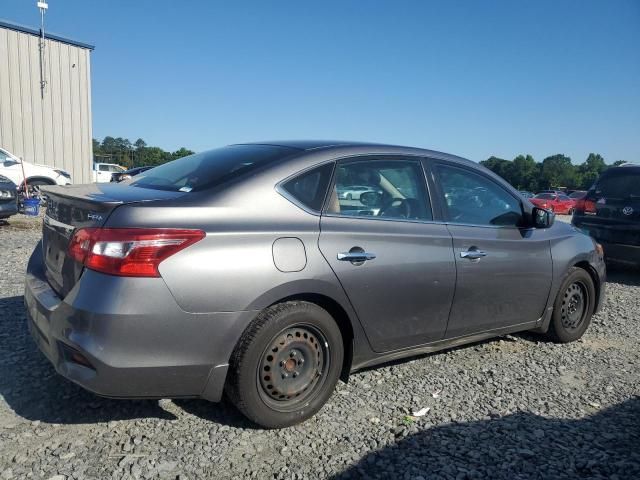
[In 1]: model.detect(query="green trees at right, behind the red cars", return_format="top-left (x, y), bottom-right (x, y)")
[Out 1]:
top-left (480, 153), bottom-right (625, 193)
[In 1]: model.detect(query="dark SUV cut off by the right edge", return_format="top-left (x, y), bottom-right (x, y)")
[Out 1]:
top-left (572, 164), bottom-right (640, 265)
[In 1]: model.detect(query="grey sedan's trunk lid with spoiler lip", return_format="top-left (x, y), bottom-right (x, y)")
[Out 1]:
top-left (42, 184), bottom-right (185, 297)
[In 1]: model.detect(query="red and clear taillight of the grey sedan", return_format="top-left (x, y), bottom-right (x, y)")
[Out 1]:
top-left (68, 228), bottom-right (205, 277)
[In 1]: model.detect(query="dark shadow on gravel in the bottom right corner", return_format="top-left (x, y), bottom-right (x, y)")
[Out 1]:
top-left (333, 398), bottom-right (640, 480)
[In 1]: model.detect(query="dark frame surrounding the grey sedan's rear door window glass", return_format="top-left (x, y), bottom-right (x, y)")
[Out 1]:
top-left (321, 153), bottom-right (436, 224)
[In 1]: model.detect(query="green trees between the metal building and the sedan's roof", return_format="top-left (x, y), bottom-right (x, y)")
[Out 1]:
top-left (93, 136), bottom-right (195, 168)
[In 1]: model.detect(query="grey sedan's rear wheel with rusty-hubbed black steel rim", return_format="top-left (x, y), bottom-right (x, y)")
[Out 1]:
top-left (225, 301), bottom-right (344, 428)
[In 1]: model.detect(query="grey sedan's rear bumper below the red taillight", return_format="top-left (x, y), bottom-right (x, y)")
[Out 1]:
top-left (24, 245), bottom-right (255, 401)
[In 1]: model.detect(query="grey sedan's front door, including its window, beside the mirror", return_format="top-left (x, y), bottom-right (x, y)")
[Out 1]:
top-left (434, 162), bottom-right (552, 338)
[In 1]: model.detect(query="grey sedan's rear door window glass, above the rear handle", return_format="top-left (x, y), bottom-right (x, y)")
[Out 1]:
top-left (327, 159), bottom-right (433, 220)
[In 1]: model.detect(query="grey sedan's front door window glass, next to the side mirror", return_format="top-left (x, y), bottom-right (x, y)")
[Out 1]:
top-left (437, 165), bottom-right (522, 227)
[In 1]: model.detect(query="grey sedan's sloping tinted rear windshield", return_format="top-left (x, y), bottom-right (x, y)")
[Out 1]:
top-left (131, 145), bottom-right (296, 192)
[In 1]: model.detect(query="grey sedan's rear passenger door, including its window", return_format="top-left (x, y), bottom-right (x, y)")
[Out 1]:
top-left (319, 157), bottom-right (456, 352)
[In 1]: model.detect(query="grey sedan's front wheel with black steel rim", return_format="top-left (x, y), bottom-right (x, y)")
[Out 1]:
top-left (547, 267), bottom-right (596, 343)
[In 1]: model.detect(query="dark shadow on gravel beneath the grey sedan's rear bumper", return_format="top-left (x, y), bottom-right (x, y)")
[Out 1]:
top-left (0, 296), bottom-right (176, 424)
